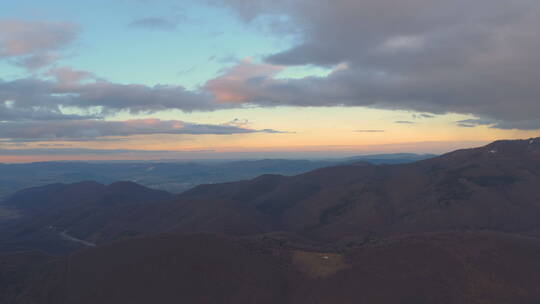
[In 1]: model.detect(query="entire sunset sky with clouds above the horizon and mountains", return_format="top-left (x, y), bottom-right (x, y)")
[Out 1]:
top-left (0, 0), bottom-right (540, 162)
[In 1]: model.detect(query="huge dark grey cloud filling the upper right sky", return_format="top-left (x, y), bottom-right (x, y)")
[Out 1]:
top-left (202, 0), bottom-right (540, 127)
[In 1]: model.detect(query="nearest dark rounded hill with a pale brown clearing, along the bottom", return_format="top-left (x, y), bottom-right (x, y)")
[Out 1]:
top-left (0, 232), bottom-right (540, 304)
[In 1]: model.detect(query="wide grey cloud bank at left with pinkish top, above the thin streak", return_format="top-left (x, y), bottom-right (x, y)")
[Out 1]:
top-left (0, 67), bottom-right (229, 121)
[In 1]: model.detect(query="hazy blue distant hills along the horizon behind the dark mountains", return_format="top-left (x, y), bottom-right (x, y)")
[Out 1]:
top-left (0, 153), bottom-right (434, 201)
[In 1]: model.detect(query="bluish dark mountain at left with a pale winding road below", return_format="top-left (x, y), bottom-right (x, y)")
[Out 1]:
top-left (0, 182), bottom-right (172, 253)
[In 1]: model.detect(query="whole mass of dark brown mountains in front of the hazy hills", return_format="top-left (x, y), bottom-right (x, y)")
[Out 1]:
top-left (0, 138), bottom-right (540, 304)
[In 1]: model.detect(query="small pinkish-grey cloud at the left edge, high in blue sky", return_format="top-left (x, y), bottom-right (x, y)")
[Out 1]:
top-left (0, 19), bottom-right (79, 70)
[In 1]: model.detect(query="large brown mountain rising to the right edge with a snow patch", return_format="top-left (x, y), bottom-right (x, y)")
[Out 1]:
top-left (177, 140), bottom-right (540, 240)
